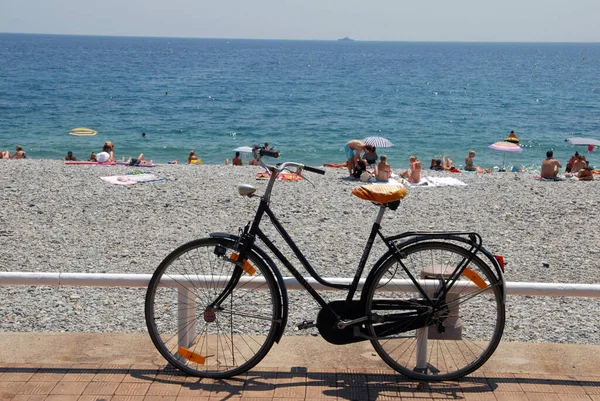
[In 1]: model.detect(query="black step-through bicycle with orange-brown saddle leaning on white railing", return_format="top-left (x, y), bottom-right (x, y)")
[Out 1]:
top-left (145, 146), bottom-right (506, 381)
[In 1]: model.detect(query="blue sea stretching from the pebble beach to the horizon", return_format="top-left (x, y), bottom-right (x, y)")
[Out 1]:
top-left (0, 33), bottom-right (600, 170)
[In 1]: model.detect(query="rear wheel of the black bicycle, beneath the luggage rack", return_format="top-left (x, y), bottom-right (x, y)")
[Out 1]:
top-left (363, 242), bottom-right (505, 381)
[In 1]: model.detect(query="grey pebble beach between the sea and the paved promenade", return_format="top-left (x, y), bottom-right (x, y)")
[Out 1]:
top-left (0, 160), bottom-right (600, 344)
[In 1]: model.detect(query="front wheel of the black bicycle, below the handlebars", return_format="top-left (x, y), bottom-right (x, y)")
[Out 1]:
top-left (145, 238), bottom-right (281, 378)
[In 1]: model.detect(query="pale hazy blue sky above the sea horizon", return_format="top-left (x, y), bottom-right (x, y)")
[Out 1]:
top-left (0, 0), bottom-right (600, 42)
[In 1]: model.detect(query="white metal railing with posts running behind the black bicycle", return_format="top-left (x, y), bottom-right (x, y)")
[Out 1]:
top-left (0, 272), bottom-right (600, 354)
